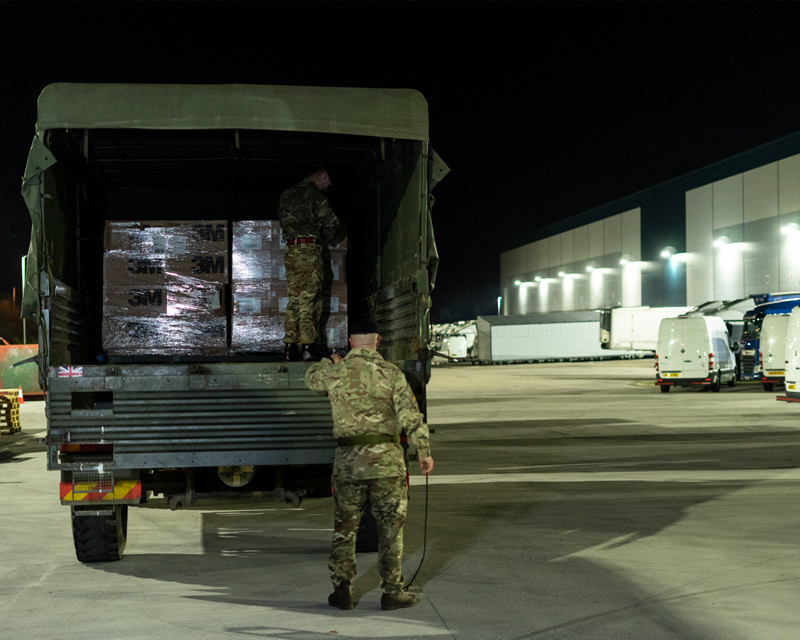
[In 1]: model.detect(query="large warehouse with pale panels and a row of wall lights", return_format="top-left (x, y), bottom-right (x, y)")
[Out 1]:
top-left (500, 132), bottom-right (800, 315)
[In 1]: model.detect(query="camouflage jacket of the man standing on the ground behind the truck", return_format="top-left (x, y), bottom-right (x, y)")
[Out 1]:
top-left (306, 349), bottom-right (431, 482)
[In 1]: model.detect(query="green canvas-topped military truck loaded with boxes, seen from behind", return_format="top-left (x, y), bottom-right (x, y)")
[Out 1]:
top-left (22, 83), bottom-right (448, 562)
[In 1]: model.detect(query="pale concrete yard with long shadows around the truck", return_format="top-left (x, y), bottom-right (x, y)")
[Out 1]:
top-left (0, 360), bottom-right (800, 640)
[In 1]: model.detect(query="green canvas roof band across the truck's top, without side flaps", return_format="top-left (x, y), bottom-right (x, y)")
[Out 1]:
top-left (37, 83), bottom-right (428, 140)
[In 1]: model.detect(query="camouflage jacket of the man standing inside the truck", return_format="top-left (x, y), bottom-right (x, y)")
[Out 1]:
top-left (278, 178), bottom-right (339, 244)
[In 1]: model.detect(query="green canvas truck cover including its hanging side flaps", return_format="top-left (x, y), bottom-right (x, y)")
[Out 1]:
top-left (22, 83), bottom-right (449, 328)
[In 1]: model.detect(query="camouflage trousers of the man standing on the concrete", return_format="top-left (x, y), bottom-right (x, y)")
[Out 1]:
top-left (328, 477), bottom-right (408, 593)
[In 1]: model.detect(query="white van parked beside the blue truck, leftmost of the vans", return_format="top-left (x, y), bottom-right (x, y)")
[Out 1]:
top-left (656, 316), bottom-right (736, 393)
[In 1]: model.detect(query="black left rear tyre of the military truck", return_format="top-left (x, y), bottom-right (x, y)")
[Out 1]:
top-left (72, 505), bottom-right (128, 562)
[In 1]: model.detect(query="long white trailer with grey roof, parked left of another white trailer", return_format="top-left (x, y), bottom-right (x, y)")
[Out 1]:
top-left (473, 311), bottom-right (633, 363)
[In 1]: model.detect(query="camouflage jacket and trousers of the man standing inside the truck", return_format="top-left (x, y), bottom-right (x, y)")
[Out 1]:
top-left (278, 178), bottom-right (339, 344)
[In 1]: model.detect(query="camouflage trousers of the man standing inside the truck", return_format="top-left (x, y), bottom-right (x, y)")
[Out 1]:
top-left (283, 242), bottom-right (322, 344)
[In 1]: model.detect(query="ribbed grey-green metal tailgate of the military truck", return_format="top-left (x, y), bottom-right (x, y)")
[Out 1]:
top-left (48, 363), bottom-right (336, 469)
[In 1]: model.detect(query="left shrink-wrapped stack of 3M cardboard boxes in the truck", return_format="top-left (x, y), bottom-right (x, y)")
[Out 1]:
top-left (103, 220), bottom-right (230, 355)
